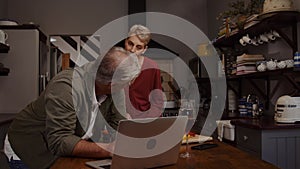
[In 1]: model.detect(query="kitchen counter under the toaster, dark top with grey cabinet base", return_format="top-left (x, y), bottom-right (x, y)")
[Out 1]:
top-left (231, 117), bottom-right (300, 169)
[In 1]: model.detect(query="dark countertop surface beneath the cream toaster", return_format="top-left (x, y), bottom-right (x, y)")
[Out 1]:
top-left (231, 117), bottom-right (300, 130)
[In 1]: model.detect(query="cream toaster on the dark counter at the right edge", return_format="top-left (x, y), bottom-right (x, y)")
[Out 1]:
top-left (274, 95), bottom-right (300, 123)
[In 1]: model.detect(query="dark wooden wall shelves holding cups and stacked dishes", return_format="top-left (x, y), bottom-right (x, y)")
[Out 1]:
top-left (213, 11), bottom-right (300, 116)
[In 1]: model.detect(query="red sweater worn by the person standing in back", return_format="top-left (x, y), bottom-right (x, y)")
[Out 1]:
top-left (125, 57), bottom-right (164, 118)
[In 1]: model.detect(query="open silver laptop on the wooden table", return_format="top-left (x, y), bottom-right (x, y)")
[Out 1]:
top-left (86, 116), bottom-right (187, 169)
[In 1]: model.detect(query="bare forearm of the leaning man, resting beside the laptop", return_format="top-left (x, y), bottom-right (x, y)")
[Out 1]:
top-left (72, 140), bottom-right (111, 158)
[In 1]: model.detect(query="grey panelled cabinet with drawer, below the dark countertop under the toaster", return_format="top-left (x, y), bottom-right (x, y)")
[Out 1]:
top-left (236, 126), bottom-right (300, 169)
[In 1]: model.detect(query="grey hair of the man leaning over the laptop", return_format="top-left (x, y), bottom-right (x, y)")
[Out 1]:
top-left (96, 47), bottom-right (141, 84)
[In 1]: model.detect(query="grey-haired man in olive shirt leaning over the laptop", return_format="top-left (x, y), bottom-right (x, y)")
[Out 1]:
top-left (6, 47), bottom-right (140, 169)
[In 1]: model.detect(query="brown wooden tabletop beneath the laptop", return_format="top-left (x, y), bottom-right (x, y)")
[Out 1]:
top-left (51, 141), bottom-right (278, 169)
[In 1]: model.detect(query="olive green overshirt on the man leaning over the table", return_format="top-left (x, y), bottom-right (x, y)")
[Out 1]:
top-left (8, 69), bottom-right (125, 169)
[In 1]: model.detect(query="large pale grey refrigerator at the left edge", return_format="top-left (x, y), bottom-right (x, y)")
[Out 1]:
top-left (0, 25), bottom-right (49, 113)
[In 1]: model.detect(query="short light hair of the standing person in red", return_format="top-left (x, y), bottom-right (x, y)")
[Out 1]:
top-left (128, 25), bottom-right (151, 46)
